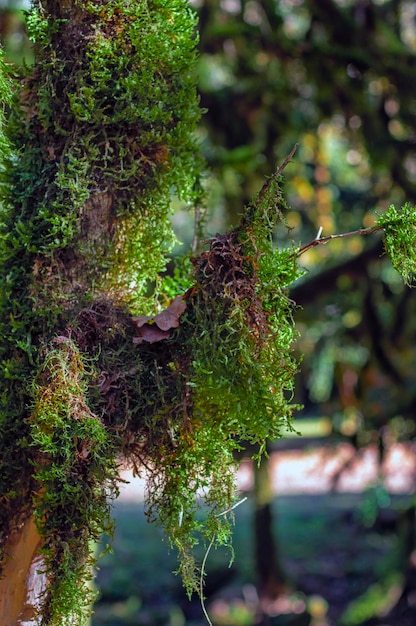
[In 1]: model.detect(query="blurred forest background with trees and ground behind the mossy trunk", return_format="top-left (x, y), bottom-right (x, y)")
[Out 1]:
top-left (0, 0), bottom-right (416, 626)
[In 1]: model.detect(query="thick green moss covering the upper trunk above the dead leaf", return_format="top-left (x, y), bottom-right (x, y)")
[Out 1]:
top-left (2, 0), bottom-right (200, 327)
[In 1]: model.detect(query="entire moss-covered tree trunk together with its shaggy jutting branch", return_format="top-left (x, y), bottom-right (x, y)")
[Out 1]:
top-left (0, 0), bottom-right (304, 626)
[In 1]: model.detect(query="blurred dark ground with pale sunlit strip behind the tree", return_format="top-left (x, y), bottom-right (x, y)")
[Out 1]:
top-left (92, 442), bottom-right (416, 626)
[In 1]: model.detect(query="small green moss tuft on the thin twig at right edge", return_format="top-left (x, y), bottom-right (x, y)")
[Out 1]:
top-left (377, 202), bottom-right (416, 286)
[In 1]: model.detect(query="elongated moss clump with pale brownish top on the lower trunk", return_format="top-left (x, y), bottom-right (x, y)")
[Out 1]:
top-left (30, 336), bottom-right (118, 624)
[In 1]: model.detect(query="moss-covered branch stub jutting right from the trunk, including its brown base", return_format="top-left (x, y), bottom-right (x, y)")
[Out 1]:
top-left (41, 171), bottom-right (299, 593)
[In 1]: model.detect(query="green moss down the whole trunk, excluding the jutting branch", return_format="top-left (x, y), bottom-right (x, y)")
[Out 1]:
top-left (0, 0), bottom-right (200, 625)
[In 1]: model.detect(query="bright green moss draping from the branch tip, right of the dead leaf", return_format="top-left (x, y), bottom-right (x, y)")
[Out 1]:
top-left (140, 168), bottom-right (299, 592)
